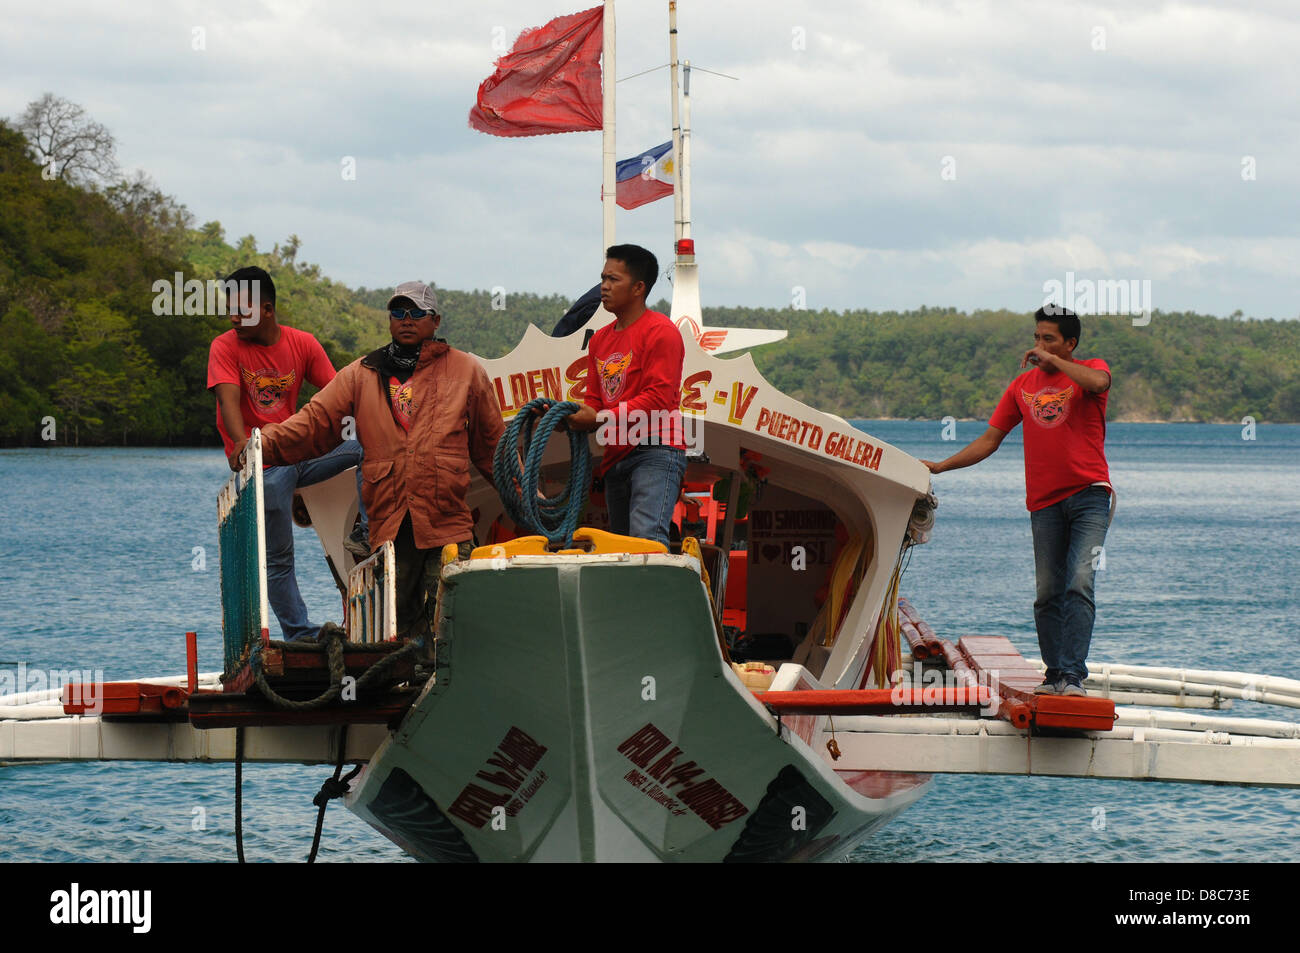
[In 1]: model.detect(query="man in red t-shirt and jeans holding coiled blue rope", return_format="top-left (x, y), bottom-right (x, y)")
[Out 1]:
top-left (568, 244), bottom-right (686, 546)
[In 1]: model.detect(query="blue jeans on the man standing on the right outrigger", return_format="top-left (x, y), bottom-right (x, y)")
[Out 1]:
top-left (1030, 486), bottom-right (1110, 683)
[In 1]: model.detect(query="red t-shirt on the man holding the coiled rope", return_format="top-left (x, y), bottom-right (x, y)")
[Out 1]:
top-left (586, 311), bottom-right (686, 473)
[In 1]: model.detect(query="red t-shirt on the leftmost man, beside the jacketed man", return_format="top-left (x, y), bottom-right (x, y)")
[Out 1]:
top-left (208, 325), bottom-right (334, 456)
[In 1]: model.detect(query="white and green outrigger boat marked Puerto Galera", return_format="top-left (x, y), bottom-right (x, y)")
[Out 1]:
top-left (0, 5), bottom-right (1300, 862)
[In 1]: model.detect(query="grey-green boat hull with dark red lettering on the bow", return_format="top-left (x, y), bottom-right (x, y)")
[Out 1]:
top-left (348, 555), bottom-right (928, 862)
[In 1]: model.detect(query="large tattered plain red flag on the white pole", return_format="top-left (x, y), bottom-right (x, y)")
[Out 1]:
top-left (469, 7), bottom-right (605, 135)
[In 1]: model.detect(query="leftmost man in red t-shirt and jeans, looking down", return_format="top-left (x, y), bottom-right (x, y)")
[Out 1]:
top-left (208, 267), bottom-right (365, 641)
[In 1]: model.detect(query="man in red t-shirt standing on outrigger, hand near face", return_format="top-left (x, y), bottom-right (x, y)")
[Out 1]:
top-left (922, 304), bottom-right (1114, 696)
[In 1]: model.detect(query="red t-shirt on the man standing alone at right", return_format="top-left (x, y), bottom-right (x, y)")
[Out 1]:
top-left (988, 358), bottom-right (1110, 512)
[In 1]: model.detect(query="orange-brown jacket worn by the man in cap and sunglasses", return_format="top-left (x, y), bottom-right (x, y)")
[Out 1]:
top-left (261, 341), bottom-right (506, 549)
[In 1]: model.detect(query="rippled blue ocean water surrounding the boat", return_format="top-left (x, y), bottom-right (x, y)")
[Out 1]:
top-left (0, 421), bottom-right (1300, 862)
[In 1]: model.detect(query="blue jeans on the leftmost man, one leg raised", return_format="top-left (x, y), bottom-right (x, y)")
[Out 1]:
top-left (261, 441), bottom-right (365, 642)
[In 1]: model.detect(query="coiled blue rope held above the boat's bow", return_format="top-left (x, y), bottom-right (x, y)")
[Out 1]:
top-left (491, 397), bottom-right (592, 547)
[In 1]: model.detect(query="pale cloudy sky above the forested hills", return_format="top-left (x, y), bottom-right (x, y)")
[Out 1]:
top-left (0, 0), bottom-right (1300, 319)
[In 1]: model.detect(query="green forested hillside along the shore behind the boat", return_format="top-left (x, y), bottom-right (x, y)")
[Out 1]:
top-left (0, 103), bottom-right (1300, 446)
